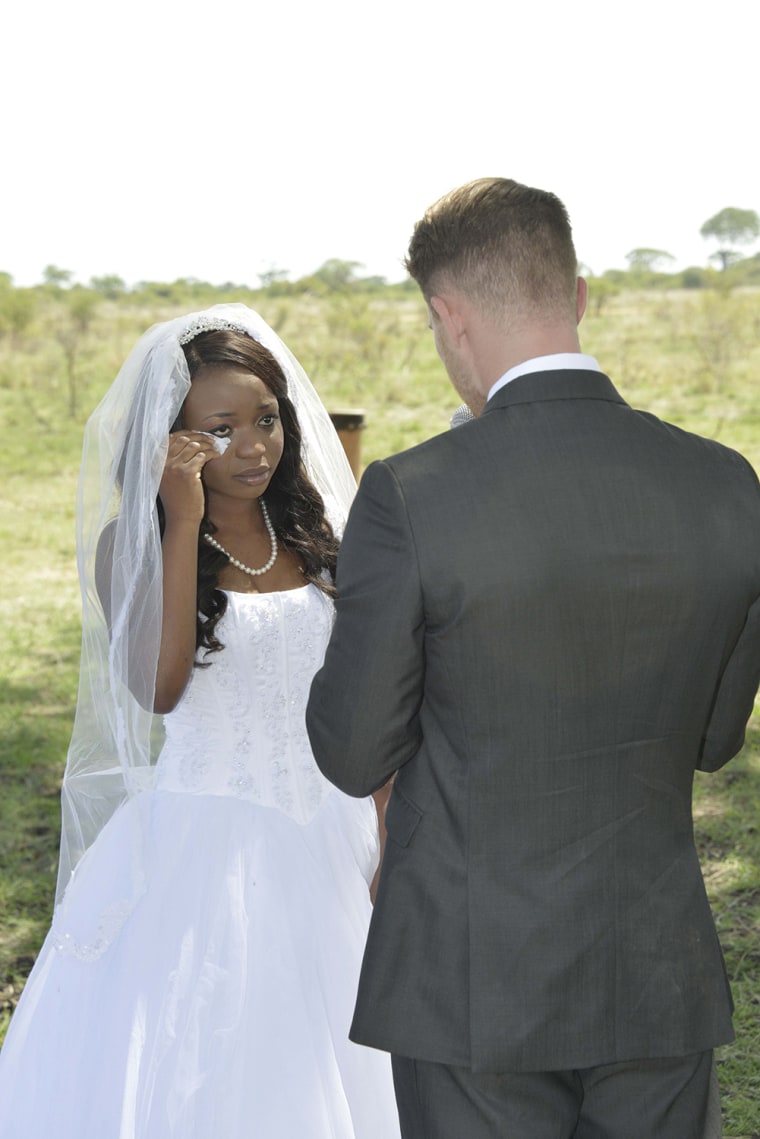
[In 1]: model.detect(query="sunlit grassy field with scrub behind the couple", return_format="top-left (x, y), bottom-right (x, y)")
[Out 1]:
top-left (0, 292), bottom-right (760, 1137)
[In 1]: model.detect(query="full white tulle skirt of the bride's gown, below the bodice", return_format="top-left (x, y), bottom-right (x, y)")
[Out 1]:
top-left (0, 792), bottom-right (399, 1139)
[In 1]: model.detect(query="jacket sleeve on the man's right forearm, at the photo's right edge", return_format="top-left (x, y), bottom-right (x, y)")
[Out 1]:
top-left (697, 598), bottom-right (760, 771)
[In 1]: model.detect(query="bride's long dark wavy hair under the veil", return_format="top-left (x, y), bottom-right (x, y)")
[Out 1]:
top-left (158, 329), bottom-right (338, 667)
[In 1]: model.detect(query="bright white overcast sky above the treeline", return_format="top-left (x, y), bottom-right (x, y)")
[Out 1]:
top-left (0, 0), bottom-right (760, 286)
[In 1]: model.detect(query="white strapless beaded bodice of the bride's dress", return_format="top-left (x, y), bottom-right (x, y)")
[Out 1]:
top-left (156, 585), bottom-right (333, 822)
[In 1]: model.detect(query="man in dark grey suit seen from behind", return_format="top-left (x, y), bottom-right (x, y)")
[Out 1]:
top-left (308, 179), bottom-right (760, 1139)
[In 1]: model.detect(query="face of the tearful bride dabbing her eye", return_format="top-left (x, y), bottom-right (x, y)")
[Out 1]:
top-left (182, 364), bottom-right (285, 499)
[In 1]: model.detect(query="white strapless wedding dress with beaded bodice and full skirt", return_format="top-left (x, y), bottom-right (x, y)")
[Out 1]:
top-left (0, 585), bottom-right (399, 1139)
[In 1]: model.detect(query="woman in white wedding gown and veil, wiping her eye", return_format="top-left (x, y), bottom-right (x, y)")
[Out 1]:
top-left (0, 305), bottom-right (399, 1139)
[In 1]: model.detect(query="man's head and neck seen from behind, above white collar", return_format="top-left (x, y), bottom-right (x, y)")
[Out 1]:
top-left (406, 178), bottom-right (586, 413)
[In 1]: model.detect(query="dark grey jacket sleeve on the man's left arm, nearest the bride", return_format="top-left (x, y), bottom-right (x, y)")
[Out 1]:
top-left (307, 462), bottom-right (425, 796)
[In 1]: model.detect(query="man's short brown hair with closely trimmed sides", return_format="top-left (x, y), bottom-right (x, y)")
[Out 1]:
top-left (404, 178), bottom-right (578, 317)
